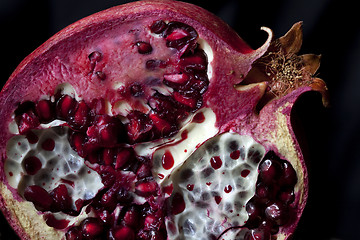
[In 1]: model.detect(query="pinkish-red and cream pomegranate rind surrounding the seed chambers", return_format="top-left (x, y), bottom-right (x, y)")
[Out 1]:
top-left (0, 0), bottom-right (326, 239)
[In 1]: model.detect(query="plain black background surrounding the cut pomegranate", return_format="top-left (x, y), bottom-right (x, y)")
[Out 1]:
top-left (0, 0), bottom-right (360, 240)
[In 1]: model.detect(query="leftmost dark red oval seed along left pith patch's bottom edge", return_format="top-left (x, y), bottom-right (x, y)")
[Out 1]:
top-left (24, 185), bottom-right (53, 211)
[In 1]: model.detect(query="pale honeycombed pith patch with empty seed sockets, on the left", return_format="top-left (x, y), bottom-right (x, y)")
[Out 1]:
top-left (4, 127), bottom-right (103, 203)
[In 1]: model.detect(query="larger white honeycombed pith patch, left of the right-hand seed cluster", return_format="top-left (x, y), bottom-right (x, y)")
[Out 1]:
top-left (166, 133), bottom-right (265, 240)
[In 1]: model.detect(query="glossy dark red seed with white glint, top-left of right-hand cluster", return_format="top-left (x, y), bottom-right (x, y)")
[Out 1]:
top-left (259, 159), bottom-right (281, 184)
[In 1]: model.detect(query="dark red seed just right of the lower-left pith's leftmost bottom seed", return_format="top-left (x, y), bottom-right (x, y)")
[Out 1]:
top-left (50, 184), bottom-right (72, 211)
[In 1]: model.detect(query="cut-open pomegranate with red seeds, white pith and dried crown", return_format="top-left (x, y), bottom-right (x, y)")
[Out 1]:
top-left (0, 0), bottom-right (327, 240)
